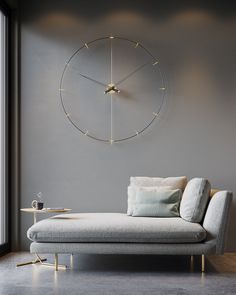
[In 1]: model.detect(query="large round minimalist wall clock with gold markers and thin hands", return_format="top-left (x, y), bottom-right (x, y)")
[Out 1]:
top-left (59, 36), bottom-right (166, 144)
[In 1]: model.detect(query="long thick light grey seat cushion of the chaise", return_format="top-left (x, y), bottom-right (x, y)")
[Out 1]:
top-left (27, 213), bottom-right (206, 243)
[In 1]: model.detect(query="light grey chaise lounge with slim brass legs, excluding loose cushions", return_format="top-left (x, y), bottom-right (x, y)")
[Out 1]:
top-left (27, 178), bottom-right (232, 271)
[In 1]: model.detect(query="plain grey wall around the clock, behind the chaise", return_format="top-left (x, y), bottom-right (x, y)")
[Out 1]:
top-left (20, 0), bottom-right (236, 251)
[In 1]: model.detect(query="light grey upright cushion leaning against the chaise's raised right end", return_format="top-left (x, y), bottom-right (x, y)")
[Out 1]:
top-left (180, 178), bottom-right (211, 222)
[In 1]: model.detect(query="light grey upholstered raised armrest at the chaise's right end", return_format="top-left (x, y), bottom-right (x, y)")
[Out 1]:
top-left (203, 191), bottom-right (233, 254)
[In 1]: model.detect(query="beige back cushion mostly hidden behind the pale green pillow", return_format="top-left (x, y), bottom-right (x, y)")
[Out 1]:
top-left (130, 176), bottom-right (187, 191)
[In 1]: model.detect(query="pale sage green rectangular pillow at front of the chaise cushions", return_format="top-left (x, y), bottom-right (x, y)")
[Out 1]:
top-left (132, 188), bottom-right (182, 217)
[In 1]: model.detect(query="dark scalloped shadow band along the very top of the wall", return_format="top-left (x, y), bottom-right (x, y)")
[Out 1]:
top-left (22, 0), bottom-right (235, 21)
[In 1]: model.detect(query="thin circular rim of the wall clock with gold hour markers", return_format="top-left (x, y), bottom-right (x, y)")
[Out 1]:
top-left (59, 36), bottom-right (166, 143)
